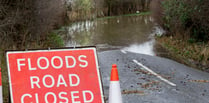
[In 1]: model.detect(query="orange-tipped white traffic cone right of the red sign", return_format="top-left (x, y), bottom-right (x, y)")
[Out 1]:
top-left (109, 64), bottom-right (122, 103)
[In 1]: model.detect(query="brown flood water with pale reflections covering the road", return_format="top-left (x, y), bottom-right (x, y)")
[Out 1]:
top-left (66, 16), bottom-right (164, 55)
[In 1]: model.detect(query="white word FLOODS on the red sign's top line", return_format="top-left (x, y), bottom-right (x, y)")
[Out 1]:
top-left (17, 55), bottom-right (88, 71)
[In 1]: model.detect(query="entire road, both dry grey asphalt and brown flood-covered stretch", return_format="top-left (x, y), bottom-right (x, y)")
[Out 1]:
top-left (66, 16), bottom-right (209, 103)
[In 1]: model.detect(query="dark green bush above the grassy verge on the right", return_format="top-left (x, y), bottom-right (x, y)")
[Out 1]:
top-left (153, 0), bottom-right (209, 41)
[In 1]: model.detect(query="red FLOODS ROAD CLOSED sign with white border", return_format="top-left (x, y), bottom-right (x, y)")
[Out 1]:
top-left (7, 47), bottom-right (104, 103)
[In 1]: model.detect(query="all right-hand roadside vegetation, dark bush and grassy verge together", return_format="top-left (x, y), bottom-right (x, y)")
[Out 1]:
top-left (151, 0), bottom-right (209, 71)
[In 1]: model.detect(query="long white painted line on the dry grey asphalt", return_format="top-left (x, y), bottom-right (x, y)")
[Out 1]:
top-left (133, 59), bottom-right (176, 87)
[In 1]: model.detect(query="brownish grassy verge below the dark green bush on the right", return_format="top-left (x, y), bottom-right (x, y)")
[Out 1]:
top-left (156, 36), bottom-right (209, 72)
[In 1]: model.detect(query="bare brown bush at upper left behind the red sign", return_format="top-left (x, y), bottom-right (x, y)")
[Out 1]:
top-left (0, 0), bottom-right (65, 50)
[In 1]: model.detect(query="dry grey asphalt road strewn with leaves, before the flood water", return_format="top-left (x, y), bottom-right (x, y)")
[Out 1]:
top-left (98, 50), bottom-right (209, 103)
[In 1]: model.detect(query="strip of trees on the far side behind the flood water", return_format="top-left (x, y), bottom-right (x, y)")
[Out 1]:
top-left (68, 0), bottom-right (152, 21)
